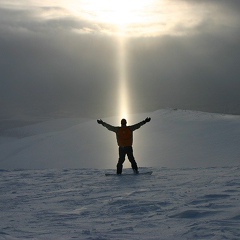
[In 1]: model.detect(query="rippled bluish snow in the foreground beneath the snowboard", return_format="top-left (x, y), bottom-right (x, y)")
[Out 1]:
top-left (0, 167), bottom-right (240, 240)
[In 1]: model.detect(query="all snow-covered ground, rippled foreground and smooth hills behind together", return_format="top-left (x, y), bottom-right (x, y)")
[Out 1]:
top-left (0, 110), bottom-right (240, 240)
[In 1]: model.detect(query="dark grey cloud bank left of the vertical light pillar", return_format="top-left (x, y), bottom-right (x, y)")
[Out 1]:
top-left (0, 5), bottom-right (120, 116)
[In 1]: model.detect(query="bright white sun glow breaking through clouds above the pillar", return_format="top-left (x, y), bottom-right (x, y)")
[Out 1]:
top-left (62, 0), bottom-right (182, 37)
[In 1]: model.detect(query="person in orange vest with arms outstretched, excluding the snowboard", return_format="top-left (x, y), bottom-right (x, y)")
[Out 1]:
top-left (97, 117), bottom-right (151, 174)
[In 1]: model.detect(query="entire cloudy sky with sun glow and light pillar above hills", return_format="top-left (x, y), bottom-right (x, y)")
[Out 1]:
top-left (0, 0), bottom-right (240, 119)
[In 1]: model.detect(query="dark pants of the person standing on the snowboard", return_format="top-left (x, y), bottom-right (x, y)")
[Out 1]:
top-left (117, 146), bottom-right (138, 174)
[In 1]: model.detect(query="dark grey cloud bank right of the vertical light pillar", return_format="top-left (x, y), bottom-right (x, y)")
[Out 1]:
top-left (125, 27), bottom-right (240, 112)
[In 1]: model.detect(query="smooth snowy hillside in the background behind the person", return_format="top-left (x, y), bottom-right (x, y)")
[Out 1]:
top-left (0, 109), bottom-right (240, 169)
